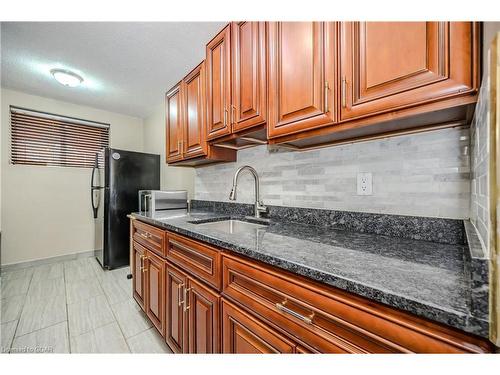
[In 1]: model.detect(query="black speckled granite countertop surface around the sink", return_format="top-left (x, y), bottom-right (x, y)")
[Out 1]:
top-left (133, 211), bottom-right (488, 337)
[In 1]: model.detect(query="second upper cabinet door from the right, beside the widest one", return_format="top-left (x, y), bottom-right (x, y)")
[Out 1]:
top-left (268, 22), bottom-right (337, 138)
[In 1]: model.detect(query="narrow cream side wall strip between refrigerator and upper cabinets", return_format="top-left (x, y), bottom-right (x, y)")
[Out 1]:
top-left (144, 104), bottom-right (195, 198)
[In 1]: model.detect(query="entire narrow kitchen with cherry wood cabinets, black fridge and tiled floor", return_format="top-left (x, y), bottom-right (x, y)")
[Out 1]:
top-left (0, 0), bottom-right (500, 370)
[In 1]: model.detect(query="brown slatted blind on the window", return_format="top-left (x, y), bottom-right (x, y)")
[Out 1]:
top-left (10, 107), bottom-right (109, 168)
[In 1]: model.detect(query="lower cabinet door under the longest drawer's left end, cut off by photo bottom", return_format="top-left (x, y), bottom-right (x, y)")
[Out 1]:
top-left (222, 300), bottom-right (295, 354)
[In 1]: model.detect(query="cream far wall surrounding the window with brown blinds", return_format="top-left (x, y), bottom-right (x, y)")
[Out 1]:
top-left (0, 89), bottom-right (143, 264)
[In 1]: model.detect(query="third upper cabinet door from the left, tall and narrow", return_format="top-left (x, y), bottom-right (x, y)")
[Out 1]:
top-left (206, 25), bottom-right (231, 139)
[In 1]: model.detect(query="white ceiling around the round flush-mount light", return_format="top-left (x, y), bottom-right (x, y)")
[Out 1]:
top-left (0, 22), bottom-right (224, 117)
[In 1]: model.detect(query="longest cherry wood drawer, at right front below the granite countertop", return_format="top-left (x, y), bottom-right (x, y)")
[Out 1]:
top-left (223, 254), bottom-right (487, 353)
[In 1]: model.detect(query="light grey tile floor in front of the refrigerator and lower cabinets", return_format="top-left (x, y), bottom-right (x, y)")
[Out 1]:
top-left (0, 258), bottom-right (170, 353)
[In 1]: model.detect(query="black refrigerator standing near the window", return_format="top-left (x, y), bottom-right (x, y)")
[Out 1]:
top-left (90, 147), bottom-right (160, 269)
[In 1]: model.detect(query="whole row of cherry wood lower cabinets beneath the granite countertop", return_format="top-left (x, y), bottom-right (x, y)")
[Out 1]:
top-left (131, 225), bottom-right (493, 353)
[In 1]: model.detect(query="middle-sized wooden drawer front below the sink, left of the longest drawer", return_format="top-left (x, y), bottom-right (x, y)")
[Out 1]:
top-left (167, 232), bottom-right (222, 291)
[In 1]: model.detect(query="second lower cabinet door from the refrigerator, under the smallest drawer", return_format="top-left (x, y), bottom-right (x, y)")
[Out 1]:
top-left (145, 251), bottom-right (165, 336)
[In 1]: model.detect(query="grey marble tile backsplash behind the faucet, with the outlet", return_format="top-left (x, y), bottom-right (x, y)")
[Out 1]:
top-left (195, 128), bottom-right (471, 219)
